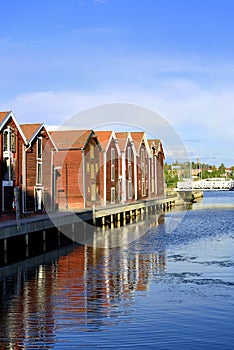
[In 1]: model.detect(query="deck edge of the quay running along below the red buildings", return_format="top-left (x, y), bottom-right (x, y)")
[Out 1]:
top-left (0, 197), bottom-right (179, 240)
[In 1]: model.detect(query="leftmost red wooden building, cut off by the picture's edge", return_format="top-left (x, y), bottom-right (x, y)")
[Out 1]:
top-left (0, 111), bottom-right (26, 213)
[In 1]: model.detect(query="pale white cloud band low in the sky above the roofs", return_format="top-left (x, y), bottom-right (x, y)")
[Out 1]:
top-left (1, 79), bottom-right (234, 164)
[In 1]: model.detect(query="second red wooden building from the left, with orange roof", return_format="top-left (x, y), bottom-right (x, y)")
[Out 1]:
top-left (20, 123), bottom-right (56, 214)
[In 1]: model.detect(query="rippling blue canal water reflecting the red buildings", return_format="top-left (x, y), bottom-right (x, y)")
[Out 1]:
top-left (0, 191), bottom-right (234, 350)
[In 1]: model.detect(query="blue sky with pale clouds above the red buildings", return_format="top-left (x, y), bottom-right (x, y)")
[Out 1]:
top-left (0, 0), bottom-right (234, 166)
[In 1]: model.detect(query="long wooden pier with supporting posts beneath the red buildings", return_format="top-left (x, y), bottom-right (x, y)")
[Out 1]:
top-left (0, 196), bottom-right (177, 254)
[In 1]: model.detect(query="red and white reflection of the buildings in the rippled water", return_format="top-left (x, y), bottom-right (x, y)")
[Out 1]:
top-left (0, 215), bottom-right (166, 349)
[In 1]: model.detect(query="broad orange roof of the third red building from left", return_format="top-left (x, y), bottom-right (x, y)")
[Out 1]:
top-left (49, 130), bottom-right (97, 150)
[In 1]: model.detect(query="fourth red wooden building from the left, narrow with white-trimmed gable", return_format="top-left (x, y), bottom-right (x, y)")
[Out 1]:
top-left (95, 131), bottom-right (121, 206)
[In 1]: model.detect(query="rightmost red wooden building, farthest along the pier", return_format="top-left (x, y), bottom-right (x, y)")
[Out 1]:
top-left (148, 139), bottom-right (165, 197)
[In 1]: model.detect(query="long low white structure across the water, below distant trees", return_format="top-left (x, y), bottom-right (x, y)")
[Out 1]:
top-left (177, 178), bottom-right (234, 191)
